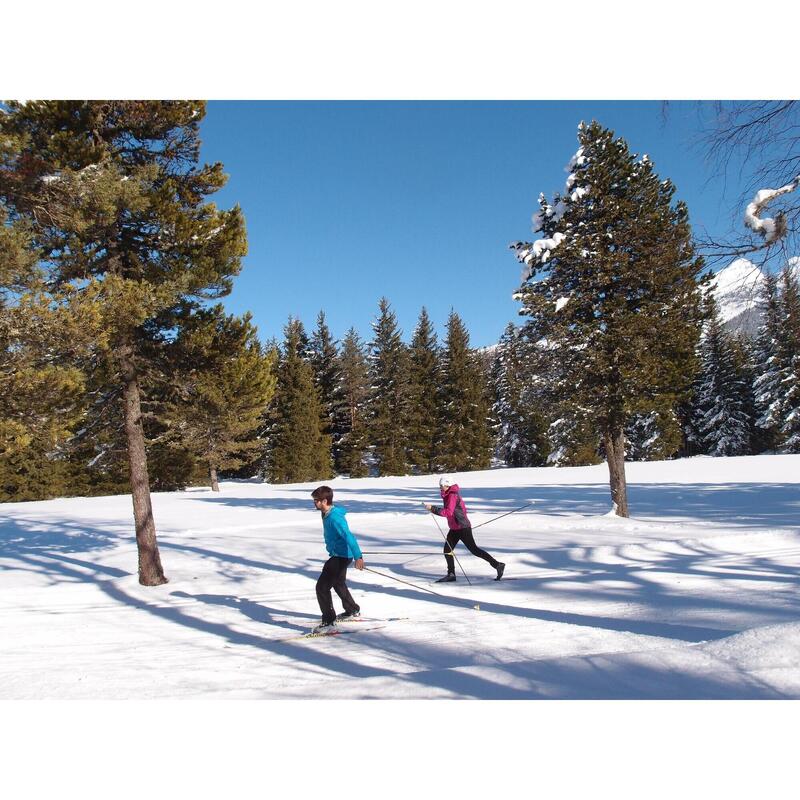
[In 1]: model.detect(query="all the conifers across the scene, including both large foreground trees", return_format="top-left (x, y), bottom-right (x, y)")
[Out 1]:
top-left (0, 106), bottom-right (800, 528)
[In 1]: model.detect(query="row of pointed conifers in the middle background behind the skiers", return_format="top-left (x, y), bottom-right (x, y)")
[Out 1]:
top-left (260, 298), bottom-right (494, 483)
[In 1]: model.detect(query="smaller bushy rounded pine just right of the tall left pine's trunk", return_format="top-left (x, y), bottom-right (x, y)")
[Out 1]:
top-left (161, 306), bottom-right (275, 491)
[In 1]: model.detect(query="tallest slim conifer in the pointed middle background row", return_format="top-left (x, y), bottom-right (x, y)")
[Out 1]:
top-left (368, 297), bottom-right (408, 475)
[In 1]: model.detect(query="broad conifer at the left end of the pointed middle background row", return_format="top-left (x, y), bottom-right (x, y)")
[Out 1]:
top-left (267, 319), bottom-right (333, 483)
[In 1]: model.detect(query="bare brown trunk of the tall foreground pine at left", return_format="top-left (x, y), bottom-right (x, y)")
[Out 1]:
top-left (117, 344), bottom-right (167, 586)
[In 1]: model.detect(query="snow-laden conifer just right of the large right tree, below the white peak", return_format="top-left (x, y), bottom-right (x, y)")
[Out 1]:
top-left (695, 298), bottom-right (752, 456)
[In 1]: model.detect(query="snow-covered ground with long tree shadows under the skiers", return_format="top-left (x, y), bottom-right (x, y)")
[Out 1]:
top-left (0, 456), bottom-right (800, 700)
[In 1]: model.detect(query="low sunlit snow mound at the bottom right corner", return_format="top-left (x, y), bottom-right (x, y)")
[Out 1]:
top-left (703, 622), bottom-right (800, 670)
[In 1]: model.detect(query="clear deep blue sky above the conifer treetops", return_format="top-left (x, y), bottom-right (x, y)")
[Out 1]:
top-left (201, 101), bottom-right (735, 347)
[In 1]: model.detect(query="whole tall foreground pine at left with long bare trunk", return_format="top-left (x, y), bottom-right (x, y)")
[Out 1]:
top-left (0, 100), bottom-right (246, 585)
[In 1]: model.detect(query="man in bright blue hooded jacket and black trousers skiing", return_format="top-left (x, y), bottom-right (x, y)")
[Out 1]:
top-left (311, 486), bottom-right (364, 633)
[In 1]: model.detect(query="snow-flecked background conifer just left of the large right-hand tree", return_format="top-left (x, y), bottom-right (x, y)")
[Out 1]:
top-left (491, 323), bottom-right (549, 467)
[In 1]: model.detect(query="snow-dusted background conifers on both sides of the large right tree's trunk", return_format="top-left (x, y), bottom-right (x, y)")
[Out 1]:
top-left (492, 267), bottom-right (800, 466)
